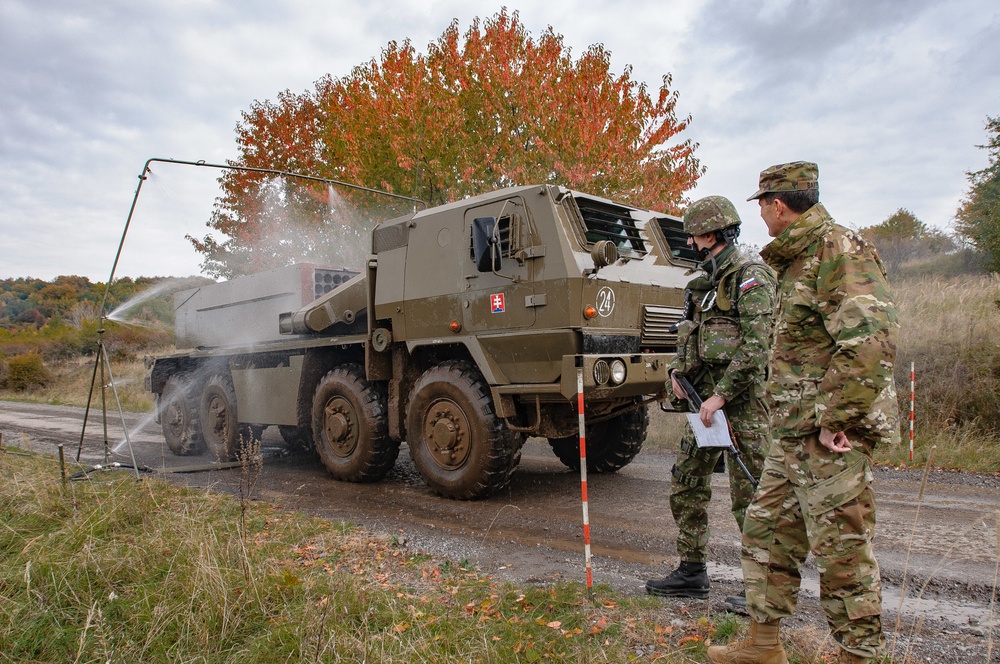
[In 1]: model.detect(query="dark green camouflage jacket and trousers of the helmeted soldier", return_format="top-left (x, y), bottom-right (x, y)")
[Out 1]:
top-left (669, 245), bottom-right (775, 563)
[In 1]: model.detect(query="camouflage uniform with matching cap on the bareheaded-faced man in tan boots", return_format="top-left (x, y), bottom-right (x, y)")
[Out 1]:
top-left (744, 167), bottom-right (899, 661)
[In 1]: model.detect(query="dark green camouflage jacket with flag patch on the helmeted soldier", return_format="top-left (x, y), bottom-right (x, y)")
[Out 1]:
top-left (669, 245), bottom-right (775, 403)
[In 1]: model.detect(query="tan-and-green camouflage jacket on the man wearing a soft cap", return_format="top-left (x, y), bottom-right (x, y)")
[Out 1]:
top-left (761, 204), bottom-right (899, 444)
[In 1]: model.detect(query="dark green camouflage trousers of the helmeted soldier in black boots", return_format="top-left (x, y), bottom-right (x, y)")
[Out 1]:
top-left (670, 396), bottom-right (768, 563)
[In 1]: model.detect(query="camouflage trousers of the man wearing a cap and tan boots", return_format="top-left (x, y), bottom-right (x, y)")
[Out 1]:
top-left (743, 433), bottom-right (885, 657)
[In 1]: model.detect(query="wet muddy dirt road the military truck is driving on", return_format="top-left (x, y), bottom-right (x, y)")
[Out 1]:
top-left (0, 402), bottom-right (1000, 662)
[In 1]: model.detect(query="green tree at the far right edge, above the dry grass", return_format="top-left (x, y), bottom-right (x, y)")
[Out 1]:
top-left (955, 116), bottom-right (1000, 271)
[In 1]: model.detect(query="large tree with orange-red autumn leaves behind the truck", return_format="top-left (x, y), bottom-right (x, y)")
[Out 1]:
top-left (189, 9), bottom-right (704, 277)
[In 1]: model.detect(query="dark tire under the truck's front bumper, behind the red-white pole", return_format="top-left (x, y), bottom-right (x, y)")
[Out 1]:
top-left (549, 408), bottom-right (649, 473)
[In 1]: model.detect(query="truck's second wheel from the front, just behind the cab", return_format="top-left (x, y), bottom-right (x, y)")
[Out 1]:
top-left (312, 364), bottom-right (399, 482)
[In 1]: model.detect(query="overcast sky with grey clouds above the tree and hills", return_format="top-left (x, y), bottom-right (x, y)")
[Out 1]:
top-left (0, 0), bottom-right (1000, 281)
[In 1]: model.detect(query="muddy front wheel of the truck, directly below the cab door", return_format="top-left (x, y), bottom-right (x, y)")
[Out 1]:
top-left (406, 361), bottom-right (520, 500)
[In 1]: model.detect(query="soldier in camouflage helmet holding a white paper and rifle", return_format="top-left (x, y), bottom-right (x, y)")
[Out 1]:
top-left (646, 196), bottom-right (775, 610)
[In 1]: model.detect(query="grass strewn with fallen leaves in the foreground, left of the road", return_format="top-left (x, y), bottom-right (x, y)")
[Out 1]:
top-left (0, 450), bottom-right (836, 662)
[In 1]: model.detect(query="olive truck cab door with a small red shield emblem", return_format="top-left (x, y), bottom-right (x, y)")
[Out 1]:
top-left (462, 196), bottom-right (544, 332)
